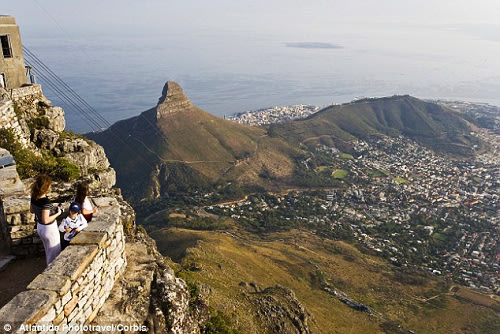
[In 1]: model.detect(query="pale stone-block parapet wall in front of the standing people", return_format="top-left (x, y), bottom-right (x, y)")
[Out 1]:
top-left (0, 197), bottom-right (127, 333)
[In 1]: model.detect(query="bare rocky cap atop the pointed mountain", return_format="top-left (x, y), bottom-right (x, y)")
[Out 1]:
top-left (156, 81), bottom-right (193, 119)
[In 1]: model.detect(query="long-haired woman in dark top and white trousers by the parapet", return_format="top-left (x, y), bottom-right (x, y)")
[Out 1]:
top-left (31, 175), bottom-right (62, 265)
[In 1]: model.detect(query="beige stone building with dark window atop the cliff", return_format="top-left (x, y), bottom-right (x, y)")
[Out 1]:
top-left (0, 15), bottom-right (28, 89)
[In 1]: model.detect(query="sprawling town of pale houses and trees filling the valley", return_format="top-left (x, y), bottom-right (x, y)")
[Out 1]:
top-left (223, 103), bottom-right (500, 295)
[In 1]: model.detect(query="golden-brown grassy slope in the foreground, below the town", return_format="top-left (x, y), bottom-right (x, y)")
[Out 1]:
top-left (152, 229), bottom-right (500, 333)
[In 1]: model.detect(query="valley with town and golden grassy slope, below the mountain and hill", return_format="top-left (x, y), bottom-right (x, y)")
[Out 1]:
top-left (142, 121), bottom-right (500, 333)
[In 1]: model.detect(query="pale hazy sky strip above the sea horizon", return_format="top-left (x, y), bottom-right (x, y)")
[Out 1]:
top-left (0, 0), bottom-right (500, 37)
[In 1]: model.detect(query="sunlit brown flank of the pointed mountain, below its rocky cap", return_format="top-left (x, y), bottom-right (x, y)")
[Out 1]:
top-left (159, 108), bottom-right (298, 184)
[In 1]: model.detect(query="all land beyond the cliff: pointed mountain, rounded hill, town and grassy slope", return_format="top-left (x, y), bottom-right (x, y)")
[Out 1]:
top-left (92, 82), bottom-right (500, 333)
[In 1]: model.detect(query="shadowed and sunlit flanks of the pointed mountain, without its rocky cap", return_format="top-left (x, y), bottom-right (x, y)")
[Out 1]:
top-left (88, 107), bottom-right (301, 197)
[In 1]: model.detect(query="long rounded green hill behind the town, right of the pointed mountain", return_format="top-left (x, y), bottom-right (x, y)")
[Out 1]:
top-left (269, 96), bottom-right (480, 156)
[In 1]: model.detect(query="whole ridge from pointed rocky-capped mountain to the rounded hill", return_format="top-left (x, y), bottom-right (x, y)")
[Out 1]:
top-left (88, 81), bottom-right (480, 200)
